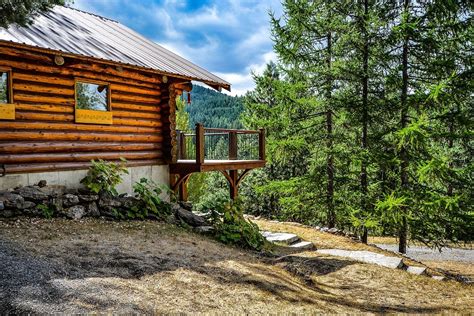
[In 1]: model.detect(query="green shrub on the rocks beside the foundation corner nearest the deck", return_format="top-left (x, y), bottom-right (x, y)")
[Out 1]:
top-left (131, 178), bottom-right (171, 219)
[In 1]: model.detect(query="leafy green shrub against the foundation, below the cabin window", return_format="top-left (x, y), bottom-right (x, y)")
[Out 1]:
top-left (81, 158), bottom-right (128, 196)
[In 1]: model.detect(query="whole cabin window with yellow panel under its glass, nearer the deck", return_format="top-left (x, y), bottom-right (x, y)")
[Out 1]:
top-left (75, 79), bottom-right (112, 124)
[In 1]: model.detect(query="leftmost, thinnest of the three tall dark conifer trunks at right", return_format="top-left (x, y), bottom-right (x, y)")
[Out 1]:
top-left (326, 33), bottom-right (336, 228)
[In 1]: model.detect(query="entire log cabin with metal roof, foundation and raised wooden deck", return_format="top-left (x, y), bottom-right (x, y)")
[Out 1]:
top-left (0, 6), bottom-right (265, 199)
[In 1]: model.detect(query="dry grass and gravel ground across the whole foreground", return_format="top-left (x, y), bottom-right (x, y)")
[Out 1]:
top-left (0, 219), bottom-right (474, 314)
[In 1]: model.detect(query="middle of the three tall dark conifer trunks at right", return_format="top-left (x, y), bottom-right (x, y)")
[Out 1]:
top-left (360, 0), bottom-right (369, 243)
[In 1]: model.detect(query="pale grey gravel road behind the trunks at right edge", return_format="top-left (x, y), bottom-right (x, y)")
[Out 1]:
top-left (376, 244), bottom-right (474, 263)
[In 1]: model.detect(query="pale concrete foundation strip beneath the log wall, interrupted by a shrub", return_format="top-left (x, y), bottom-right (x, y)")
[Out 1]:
top-left (0, 165), bottom-right (169, 194)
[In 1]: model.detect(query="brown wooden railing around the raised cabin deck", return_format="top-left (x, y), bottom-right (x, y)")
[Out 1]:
top-left (178, 124), bottom-right (265, 163)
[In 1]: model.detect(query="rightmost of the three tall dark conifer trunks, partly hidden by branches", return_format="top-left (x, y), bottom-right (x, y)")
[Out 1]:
top-left (398, 0), bottom-right (410, 253)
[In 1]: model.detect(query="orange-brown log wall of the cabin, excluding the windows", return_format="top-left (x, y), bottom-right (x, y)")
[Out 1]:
top-left (0, 45), bottom-right (174, 173)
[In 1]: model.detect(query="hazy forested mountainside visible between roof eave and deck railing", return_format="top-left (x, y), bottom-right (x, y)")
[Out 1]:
top-left (183, 85), bottom-right (244, 128)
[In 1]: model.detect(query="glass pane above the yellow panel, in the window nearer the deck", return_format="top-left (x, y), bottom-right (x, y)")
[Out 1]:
top-left (76, 82), bottom-right (108, 111)
